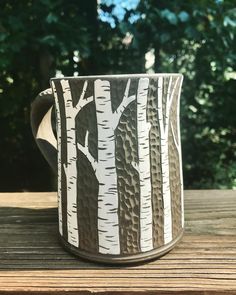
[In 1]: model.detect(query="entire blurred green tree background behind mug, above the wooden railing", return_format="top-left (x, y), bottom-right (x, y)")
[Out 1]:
top-left (0, 0), bottom-right (236, 191)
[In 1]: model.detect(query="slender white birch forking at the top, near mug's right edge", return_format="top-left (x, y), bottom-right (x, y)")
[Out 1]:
top-left (157, 77), bottom-right (179, 244)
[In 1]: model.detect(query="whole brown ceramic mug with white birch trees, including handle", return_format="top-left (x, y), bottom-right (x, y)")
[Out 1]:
top-left (31, 74), bottom-right (184, 263)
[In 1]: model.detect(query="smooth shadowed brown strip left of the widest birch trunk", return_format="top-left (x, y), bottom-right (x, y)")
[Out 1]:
top-left (70, 80), bottom-right (98, 253)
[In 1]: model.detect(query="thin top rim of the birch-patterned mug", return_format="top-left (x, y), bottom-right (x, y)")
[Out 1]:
top-left (50, 73), bottom-right (183, 81)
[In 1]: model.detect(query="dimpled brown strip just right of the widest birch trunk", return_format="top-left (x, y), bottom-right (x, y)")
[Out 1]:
top-left (114, 79), bottom-right (140, 254)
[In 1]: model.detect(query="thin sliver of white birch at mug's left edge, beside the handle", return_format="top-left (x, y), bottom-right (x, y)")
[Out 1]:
top-left (52, 81), bottom-right (63, 235)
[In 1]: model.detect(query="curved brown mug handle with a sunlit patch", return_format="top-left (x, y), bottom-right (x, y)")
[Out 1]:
top-left (30, 88), bottom-right (57, 173)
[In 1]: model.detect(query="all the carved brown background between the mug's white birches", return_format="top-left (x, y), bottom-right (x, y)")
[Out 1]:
top-left (52, 76), bottom-right (181, 255)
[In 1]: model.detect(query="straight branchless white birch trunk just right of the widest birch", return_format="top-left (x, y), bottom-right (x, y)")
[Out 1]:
top-left (134, 78), bottom-right (153, 252)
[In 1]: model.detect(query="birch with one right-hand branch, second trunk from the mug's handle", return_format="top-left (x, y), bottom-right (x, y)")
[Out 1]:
top-left (61, 80), bottom-right (93, 247)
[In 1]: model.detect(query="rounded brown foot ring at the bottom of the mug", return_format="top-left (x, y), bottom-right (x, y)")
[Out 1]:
top-left (59, 229), bottom-right (184, 264)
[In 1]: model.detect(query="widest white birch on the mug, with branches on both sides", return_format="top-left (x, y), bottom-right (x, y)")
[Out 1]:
top-left (78, 79), bottom-right (135, 254)
